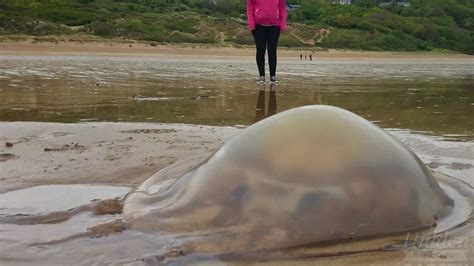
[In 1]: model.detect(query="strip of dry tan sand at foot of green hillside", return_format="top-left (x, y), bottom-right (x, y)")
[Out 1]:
top-left (0, 40), bottom-right (474, 61)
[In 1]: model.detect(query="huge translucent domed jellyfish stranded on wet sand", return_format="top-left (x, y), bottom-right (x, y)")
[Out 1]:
top-left (124, 105), bottom-right (462, 255)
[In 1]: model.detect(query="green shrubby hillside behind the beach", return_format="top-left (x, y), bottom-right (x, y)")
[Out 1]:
top-left (0, 0), bottom-right (474, 54)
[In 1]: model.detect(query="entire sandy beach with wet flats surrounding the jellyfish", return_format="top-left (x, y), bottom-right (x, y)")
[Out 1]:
top-left (0, 44), bottom-right (474, 265)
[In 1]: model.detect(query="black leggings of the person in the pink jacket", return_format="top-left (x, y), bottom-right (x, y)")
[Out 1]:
top-left (252, 24), bottom-right (280, 77)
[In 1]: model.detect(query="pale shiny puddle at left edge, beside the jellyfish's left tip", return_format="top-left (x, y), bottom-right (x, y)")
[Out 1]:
top-left (0, 185), bottom-right (130, 248)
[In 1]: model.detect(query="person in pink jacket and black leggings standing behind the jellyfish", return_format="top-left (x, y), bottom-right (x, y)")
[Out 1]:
top-left (247, 0), bottom-right (286, 83)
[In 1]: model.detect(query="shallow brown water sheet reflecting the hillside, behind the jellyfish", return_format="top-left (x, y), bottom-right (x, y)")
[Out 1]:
top-left (0, 56), bottom-right (474, 141)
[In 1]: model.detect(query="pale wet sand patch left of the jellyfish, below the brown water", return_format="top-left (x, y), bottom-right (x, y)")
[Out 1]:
top-left (0, 122), bottom-right (239, 192)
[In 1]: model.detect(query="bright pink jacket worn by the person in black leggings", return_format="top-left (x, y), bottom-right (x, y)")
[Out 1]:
top-left (247, 0), bottom-right (286, 32)
